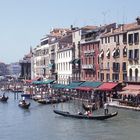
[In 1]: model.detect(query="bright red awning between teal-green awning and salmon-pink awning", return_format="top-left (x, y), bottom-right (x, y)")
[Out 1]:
top-left (97, 82), bottom-right (118, 91)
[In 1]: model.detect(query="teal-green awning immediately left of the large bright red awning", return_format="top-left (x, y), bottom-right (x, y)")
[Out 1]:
top-left (80, 81), bottom-right (102, 88)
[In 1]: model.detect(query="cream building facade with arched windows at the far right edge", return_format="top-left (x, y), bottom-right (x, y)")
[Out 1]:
top-left (127, 17), bottom-right (140, 82)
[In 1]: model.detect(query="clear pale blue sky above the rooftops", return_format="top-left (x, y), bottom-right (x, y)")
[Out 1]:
top-left (0, 0), bottom-right (140, 64)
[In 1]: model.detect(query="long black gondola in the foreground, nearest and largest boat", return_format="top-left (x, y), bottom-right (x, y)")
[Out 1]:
top-left (53, 110), bottom-right (118, 120)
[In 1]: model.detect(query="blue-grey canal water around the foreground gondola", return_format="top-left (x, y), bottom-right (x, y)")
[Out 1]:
top-left (0, 93), bottom-right (140, 140)
